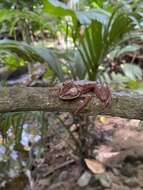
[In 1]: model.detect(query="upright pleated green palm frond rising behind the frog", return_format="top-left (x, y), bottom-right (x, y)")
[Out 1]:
top-left (78, 8), bottom-right (135, 80)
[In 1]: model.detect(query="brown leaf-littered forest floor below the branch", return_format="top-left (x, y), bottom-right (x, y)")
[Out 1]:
top-left (29, 116), bottom-right (143, 190)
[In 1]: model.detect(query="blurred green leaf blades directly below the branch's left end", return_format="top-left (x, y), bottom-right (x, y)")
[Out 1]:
top-left (0, 112), bottom-right (43, 145)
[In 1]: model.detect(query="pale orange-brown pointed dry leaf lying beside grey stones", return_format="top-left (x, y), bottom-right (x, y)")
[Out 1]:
top-left (84, 159), bottom-right (105, 174)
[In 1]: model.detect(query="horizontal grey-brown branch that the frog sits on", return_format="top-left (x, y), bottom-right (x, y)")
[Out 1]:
top-left (0, 86), bottom-right (143, 120)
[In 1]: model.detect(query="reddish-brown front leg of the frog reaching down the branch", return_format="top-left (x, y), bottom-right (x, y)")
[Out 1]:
top-left (74, 96), bottom-right (92, 115)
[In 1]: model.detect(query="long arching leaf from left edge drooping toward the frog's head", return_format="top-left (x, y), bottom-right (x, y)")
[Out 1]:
top-left (0, 40), bottom-right (63, 81)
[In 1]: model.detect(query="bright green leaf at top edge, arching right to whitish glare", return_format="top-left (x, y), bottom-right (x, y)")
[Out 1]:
top-left (43, 0), bottom-right (110, 25)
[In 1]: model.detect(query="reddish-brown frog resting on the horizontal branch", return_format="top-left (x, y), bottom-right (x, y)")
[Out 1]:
top-left (59, 80), bottom-right (112, 114)
